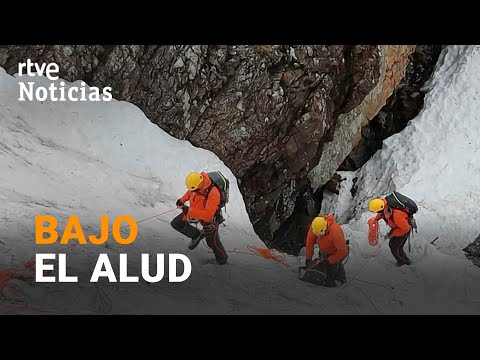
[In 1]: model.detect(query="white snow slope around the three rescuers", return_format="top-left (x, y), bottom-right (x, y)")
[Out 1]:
top-left (0, 47), bottom-right (480, 314)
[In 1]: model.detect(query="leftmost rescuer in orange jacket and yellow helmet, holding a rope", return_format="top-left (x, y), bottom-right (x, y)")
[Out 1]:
top-left (170, 172), bottom-right (228, 265)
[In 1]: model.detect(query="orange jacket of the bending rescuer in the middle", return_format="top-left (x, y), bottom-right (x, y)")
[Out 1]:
top-left (306, 215), bottom-right (348, 264)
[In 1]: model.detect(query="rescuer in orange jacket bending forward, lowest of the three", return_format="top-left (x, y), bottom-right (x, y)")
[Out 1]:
top-left (305, 215), bottom-right (348, 287)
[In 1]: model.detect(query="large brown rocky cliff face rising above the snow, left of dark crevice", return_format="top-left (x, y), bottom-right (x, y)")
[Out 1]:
top-left (0, 45), bottom-right (415, 253)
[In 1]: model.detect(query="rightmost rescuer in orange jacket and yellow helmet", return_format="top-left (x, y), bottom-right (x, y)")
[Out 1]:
top-left (368, 198), bottom-right (411, 266)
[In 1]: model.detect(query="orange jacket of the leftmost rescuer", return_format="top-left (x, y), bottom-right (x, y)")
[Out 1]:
top-left (180, 172), bottom-right (220, 222)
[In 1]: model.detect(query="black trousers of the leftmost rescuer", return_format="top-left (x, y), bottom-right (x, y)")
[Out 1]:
top-left (170, 214), bottom-right (228, 264)
